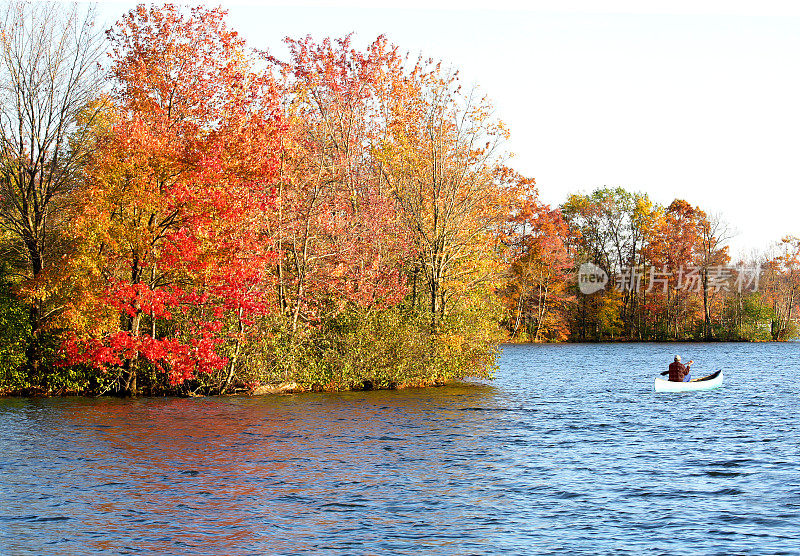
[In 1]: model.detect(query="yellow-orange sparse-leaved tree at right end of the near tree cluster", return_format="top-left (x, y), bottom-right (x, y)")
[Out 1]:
top-left (381, 62), bottom-right (517, 330)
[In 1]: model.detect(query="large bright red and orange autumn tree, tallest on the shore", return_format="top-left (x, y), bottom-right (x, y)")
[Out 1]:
top-left (67, 5), bottom-right (279, 392)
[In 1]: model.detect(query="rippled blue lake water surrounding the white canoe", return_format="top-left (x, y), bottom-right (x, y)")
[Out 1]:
top-left (0, 343), bottom-right (800, 555)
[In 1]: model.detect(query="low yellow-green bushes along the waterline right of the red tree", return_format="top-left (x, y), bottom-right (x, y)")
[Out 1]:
top-left (222, 295), bottom-right (501, 391)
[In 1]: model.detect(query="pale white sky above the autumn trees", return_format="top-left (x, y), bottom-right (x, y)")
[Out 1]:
top-left (95, 0), bottom-right (800, 252)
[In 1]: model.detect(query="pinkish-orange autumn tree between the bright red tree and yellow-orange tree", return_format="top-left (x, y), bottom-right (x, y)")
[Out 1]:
top-left (272, 36), bottom-right (408, 333)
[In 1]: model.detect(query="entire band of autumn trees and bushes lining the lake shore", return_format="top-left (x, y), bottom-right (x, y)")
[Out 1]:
top-left (0, 3), bottom-right (800, 394)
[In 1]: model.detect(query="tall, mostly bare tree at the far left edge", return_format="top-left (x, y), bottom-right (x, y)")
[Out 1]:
top-left (0, 1), bottom-right (103, 331)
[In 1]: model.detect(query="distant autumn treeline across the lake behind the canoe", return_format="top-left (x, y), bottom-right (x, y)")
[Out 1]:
top-left (500, 188), bottom-right (800, 341)
